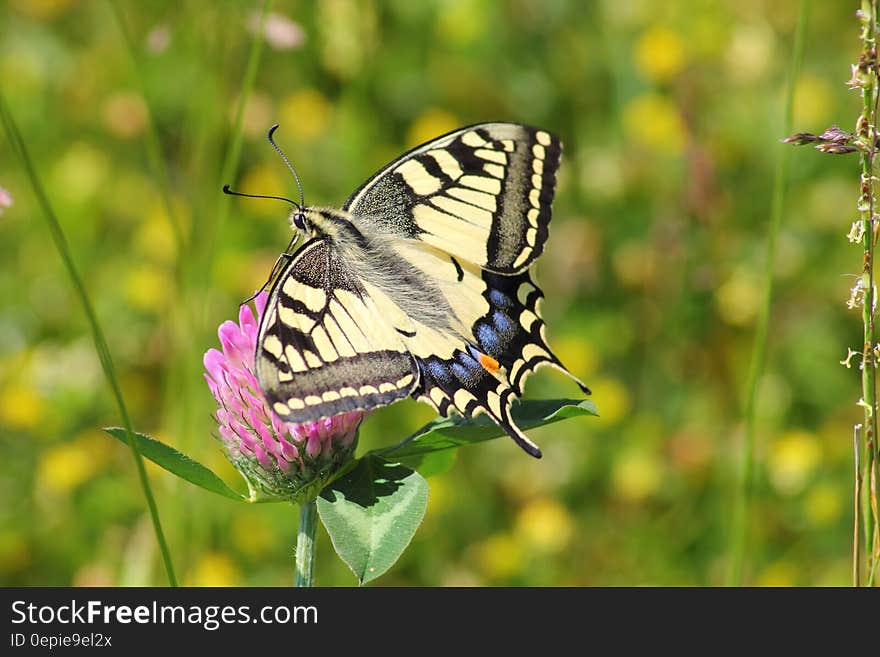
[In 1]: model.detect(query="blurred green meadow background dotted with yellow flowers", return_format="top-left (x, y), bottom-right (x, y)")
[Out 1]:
top-left (0, 0), bottom-right (861, 586)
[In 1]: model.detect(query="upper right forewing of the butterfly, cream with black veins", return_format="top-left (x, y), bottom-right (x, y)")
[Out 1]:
top-left (343, 123), bottom-right (562, 274)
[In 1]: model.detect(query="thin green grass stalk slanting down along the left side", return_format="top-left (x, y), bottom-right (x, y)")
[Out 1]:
top-left (0, 94), bottom-right (177, 586)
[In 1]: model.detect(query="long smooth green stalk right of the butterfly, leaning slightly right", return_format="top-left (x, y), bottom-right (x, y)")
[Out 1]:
top-left (727, 0), bottom-right (810, 586)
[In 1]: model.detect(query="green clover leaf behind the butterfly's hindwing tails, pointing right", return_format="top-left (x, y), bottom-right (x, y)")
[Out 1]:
top-left (369, 399), bottom-right (599, 462)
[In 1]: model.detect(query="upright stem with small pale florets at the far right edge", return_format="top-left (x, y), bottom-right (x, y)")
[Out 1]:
top-left (856, 0), bottom-right (880, 586)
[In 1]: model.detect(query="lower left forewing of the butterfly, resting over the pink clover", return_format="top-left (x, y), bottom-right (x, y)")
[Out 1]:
top-left (256, 239), bottom-right (419, 423)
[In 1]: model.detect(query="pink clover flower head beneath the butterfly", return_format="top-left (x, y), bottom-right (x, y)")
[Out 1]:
top-left (205, 292), bottom-right (364, 500)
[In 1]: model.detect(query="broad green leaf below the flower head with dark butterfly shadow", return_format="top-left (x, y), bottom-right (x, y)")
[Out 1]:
top-left (318, 456), bottom-right (428, 584)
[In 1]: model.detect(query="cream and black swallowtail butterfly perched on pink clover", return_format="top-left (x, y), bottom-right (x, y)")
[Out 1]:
top-left (224, 123), bottom-right (590, 458)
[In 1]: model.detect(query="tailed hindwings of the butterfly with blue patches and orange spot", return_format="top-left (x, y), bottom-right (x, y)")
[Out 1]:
top-left (386, 242), bottom-right (589, 457)
